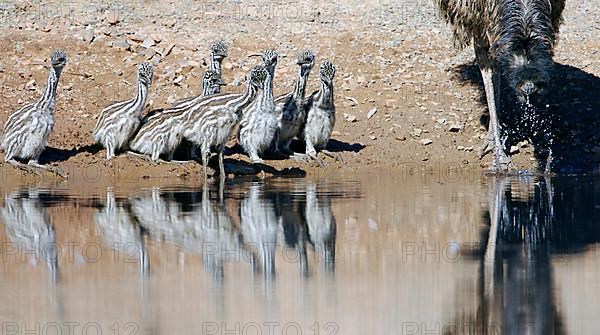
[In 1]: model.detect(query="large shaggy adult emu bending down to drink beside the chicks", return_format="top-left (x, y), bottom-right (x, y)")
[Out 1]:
top-left (435, 0), bottom-right (565, 171)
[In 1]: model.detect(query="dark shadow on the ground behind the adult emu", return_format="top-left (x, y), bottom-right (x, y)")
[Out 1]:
top-left (454, 63), bottom-right (600, 174)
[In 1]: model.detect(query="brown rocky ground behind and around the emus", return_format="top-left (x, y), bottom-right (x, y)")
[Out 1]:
top-left (0, 0), bottom-right (600, 181)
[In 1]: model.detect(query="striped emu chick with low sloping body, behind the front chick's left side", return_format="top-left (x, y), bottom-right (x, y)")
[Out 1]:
top-left (129, 71), bottom-right (235, 163)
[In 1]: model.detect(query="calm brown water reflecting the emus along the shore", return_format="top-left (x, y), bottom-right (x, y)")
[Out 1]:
top-left (0, 173), bottom-right (600, 334)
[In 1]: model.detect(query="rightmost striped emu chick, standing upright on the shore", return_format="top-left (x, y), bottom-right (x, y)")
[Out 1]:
top-left (303, 60), bottom-right (335, 157)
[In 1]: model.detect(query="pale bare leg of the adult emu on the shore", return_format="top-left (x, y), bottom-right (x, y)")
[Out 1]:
top-left (475, 37), bottom-right (511, 172)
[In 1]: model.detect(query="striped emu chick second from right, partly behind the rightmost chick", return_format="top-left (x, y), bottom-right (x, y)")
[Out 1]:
top-left (275, 50), bottom-right (315, 154)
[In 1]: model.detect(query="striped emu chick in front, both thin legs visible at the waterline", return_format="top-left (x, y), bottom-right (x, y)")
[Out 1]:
top-left (182, 65), bottom-right (269, 180)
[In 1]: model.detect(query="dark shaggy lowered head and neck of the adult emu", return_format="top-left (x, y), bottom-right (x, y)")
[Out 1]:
top-left (493, 0), bottom-right (557, 102)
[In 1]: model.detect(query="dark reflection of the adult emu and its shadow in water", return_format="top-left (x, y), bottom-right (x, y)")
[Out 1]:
top-left (444, 177), bottom-right (600, 334)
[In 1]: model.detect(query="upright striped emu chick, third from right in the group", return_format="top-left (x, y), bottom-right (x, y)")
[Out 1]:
top-left (238, 50), bottom-right (279, 163)
